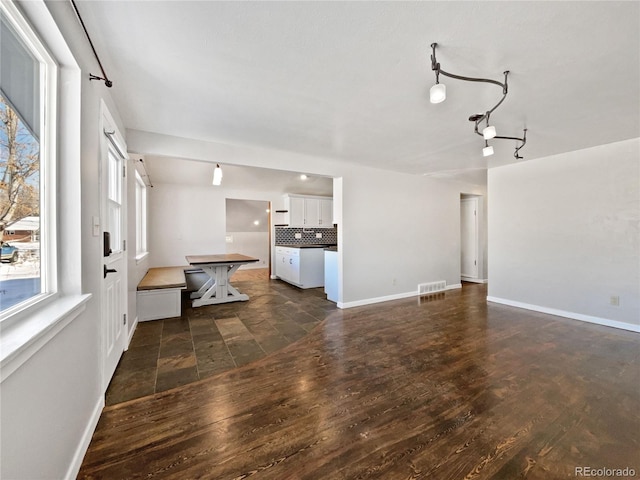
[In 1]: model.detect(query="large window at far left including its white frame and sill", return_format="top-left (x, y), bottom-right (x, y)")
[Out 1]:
top-left (0, 0), bottom-right (87, 383)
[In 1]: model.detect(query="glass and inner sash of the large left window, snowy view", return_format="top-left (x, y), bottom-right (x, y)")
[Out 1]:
top-left (0, 2), bottom-right (56, 319)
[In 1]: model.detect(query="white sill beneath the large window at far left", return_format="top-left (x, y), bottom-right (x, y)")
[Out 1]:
top-left (0, 294), bottom-right (91, 383)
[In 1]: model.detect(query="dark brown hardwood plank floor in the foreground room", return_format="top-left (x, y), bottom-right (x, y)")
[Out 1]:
top-left (79, 281), bottom-right (640, 480)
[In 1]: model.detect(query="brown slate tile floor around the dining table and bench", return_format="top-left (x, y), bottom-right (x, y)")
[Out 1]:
top-left (106, 269), bottom-right (336, 405)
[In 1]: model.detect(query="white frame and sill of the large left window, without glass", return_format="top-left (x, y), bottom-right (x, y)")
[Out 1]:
top-left (0, 0), bottom-right (91, 382)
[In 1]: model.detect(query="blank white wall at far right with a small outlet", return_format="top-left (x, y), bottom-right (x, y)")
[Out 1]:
top-left (488, 135), bottom-right (640, 329)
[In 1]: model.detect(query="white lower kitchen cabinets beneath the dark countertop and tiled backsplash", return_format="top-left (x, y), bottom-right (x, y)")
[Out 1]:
top-left (275, 246), bottom-right (324, 288)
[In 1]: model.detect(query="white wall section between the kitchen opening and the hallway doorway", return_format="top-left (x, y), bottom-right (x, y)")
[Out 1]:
top-left (339, 170), bottom-right (483, 306)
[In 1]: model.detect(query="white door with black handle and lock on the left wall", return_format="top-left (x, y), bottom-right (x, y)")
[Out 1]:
top-left (100, 107), bottom-right (127, 391)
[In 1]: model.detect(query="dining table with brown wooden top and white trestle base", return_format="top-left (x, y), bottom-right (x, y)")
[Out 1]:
top-left (186, 253), bottom-right (259, 307)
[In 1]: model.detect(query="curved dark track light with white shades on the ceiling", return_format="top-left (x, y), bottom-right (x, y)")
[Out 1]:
top-left (429, 43), bottom-right (527, 159)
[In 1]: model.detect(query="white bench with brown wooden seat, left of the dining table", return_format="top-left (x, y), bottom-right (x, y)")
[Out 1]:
top-left (137, 266), bottom-right (192, 322)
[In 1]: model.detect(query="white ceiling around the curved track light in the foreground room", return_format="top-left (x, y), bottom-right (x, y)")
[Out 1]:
top-left (77, 0), bottom-right (640, 182)
